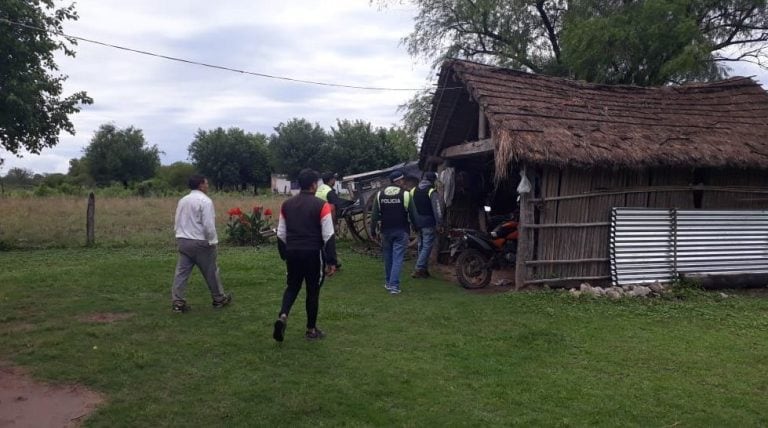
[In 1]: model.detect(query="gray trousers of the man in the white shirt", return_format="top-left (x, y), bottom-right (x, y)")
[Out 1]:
top-left (171, 238), bottom-right (224, 302)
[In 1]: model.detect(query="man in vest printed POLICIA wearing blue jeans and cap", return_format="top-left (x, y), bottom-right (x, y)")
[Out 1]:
top-left (371, 171), bottom-right (413, 294)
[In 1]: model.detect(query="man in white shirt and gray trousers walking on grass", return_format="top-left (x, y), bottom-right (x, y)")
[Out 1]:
top-left (171, 175), bottom-right (232, 313)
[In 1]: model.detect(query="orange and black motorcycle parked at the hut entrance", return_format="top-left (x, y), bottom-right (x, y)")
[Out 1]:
top-left (449, 216), bottom-right (518, 289)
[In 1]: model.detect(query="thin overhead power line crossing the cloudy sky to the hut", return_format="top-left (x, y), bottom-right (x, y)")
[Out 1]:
top-left (0, 18), bottom-right (461, 91)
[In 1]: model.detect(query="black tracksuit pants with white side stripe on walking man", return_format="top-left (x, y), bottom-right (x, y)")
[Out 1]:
top-left (280, 250), bottom-right (325, 329)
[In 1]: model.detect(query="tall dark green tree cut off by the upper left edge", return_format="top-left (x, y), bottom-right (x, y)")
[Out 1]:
top-left (0, 0), bottom-right (92, 159)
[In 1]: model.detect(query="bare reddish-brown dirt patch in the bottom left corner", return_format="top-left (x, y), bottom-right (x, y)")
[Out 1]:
top-left (0, 362), bottom-right (104, 428)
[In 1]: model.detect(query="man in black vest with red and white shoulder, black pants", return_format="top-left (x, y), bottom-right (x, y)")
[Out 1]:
top-left (272, 169), bottom-right (336, 342)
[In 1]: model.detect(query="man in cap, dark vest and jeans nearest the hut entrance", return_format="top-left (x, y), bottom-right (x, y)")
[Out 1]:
top-left (411, 172), bottom-right (445, 278)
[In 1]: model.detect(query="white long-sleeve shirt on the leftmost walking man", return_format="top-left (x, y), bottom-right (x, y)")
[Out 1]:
top-left (174, 190), bottom-right (219, 245)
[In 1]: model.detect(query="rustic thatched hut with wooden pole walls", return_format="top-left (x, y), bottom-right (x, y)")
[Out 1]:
top-left (420, 60), bottom-right (768, 286)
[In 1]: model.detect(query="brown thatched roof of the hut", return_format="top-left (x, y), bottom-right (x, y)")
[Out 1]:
top-left (421, 60), bottom-right (768, 173)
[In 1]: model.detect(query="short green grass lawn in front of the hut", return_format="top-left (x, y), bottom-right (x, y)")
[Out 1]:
top-left (0, 247), bottom-right (768, 427)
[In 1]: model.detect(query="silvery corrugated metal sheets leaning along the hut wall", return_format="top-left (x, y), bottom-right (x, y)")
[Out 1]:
top-left (610, 208), bottom-right (768, 285)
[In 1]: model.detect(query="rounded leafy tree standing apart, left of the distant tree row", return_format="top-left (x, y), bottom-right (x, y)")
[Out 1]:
top-left (83, 124), bottom-right (160, 187)
